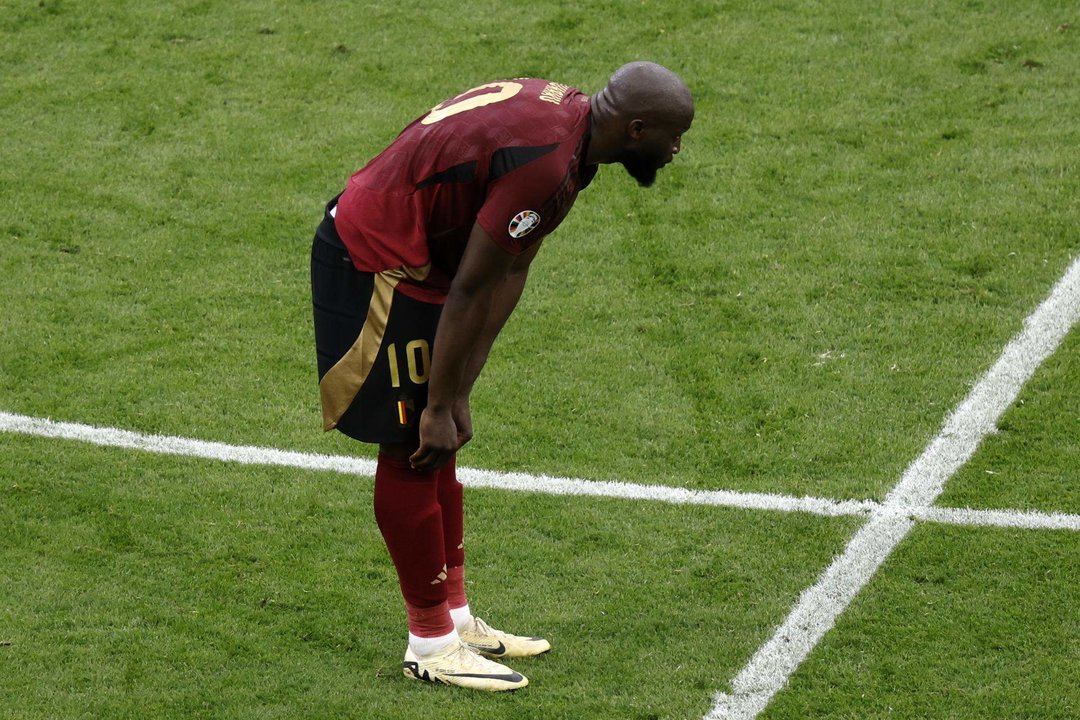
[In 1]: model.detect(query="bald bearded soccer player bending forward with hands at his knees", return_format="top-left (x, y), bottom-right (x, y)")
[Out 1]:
top-left (311, 63), bottom-right (693, 691)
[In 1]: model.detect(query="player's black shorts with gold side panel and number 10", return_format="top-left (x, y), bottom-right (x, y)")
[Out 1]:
top-left (311, 200), bottom-right (443, 444)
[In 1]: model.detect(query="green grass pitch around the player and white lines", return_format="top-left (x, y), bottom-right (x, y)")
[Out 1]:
top-left (0, 0), bottom-right (1080, 720)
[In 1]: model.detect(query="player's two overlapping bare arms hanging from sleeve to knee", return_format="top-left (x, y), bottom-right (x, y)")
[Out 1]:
top-left (409, 225), bottom-right (539, 471)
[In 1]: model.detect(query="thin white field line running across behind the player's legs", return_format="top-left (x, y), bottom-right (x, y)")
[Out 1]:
top-left (0, 411), bottom-right (1080, 530)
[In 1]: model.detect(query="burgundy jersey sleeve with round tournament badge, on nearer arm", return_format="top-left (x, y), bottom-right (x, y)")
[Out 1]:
top-left (476, 152), bottom-right (567, 255)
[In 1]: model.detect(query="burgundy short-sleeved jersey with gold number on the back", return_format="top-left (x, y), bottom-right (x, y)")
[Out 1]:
top-left (335, 79), bottom-right (596, 302)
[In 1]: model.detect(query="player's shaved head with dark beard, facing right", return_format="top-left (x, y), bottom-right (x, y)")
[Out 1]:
top-left (589, 60), bottom-right (693, 187)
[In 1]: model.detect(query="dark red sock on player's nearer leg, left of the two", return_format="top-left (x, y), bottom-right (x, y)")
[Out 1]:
top-left (375, 453), bottom-right (454, 637)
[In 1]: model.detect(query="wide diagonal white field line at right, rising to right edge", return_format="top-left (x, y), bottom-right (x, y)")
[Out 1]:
top-left (705, 258), bottom-right (1080, 720)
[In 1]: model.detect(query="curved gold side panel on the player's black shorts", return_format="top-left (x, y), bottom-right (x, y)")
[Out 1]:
top-left (319, 264), bottom-right (431, 431)
